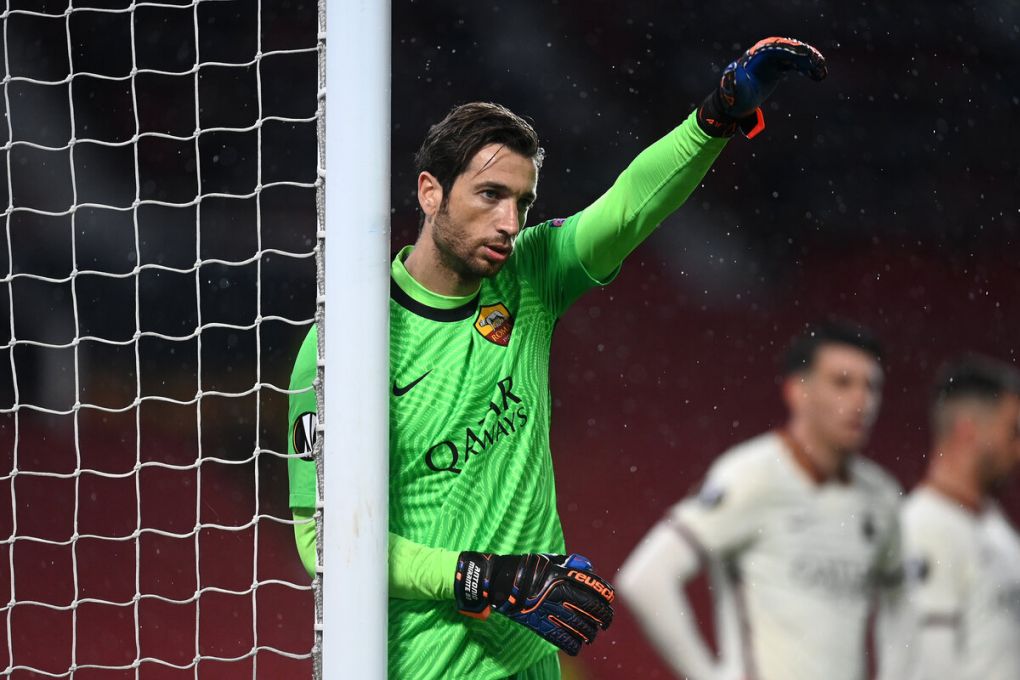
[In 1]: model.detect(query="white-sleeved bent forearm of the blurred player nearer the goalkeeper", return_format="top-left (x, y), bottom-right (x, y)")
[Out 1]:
top-left (617, 522), bottom-right (721, 680)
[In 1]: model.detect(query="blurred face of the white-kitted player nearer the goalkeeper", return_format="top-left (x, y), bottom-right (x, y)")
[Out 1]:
top-left (788, 344), bottom-right (882, 454)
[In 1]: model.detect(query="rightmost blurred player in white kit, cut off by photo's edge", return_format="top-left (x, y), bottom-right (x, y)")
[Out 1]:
top-left (900, 356), bottom-right (1020, 680)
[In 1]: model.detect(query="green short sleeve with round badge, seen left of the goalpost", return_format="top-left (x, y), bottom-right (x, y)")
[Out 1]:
top-left (287, 325), bottom-right (318, 509)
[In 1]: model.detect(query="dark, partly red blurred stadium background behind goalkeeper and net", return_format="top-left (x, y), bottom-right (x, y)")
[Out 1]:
top-left (0, 0), bottom-right (1020, 680)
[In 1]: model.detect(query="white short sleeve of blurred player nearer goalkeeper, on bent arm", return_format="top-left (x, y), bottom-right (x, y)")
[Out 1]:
top-left (667, 459), bottom-right (761, 557)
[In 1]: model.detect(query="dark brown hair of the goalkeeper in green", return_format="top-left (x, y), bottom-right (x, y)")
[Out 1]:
top-left (414, 102), bottom-right (545, 227)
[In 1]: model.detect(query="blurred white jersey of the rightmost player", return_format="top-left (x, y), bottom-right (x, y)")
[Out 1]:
top-left (902, 486), bottom-right (1020, 680)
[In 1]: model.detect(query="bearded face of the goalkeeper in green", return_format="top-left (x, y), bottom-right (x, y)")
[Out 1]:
top-left (423, 144), bottom-right (539, 278)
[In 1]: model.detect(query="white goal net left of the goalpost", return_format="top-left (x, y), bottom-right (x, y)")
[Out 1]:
top-left (0, 0), bottom-right (321, 680)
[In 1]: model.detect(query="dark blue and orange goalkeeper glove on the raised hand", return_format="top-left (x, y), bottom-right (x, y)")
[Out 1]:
top-left (698, 38), bottom-right (828, 139)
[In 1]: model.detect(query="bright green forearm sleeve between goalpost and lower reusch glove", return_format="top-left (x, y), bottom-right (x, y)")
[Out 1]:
top-left (389, 532), bottom-right (460, 600)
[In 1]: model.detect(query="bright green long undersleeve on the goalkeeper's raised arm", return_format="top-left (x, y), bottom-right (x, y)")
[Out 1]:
top-left (574, 112), bottom-right (726, 279)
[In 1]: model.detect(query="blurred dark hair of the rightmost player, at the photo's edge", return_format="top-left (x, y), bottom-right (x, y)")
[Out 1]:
top-left (931, 354), bottom-right (1020, 430)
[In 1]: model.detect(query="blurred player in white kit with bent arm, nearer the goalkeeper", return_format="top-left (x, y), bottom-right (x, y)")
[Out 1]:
top-left (617, 322), bottom-right (901, 680)
